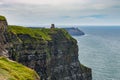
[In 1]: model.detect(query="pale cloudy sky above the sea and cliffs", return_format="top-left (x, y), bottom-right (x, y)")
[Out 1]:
top-left (0, 0), bottom-right (120, 26)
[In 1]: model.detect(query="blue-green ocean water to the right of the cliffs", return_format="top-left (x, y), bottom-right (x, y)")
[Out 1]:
top-left (74, 26), bottom-right (120, 80)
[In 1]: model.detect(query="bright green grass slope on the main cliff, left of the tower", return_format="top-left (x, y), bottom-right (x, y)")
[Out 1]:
top-left (8, 25), bottom-right (51, 40)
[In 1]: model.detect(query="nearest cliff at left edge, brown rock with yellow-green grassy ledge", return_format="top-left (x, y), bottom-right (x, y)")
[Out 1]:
top-left (0, 16), bottom-right (40, 80)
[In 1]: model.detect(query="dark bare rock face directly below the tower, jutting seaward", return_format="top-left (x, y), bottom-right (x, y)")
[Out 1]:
top-left (45, 31), bottom-right (91, 80)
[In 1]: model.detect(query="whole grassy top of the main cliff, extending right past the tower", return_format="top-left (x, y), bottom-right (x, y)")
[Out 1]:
top-left (8, 25), bottom-right (72, 40)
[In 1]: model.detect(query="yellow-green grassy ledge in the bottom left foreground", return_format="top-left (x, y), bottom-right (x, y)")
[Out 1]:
top-left (0, 57), bottom-right (39, 80)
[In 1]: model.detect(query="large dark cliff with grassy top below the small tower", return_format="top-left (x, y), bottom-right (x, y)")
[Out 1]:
top-left (5, 26), bottom-right (92, 80)
